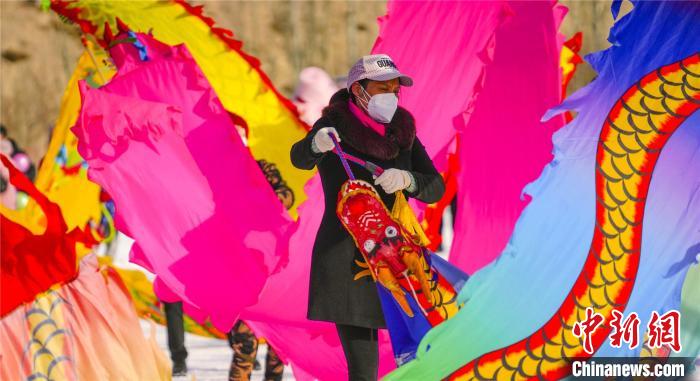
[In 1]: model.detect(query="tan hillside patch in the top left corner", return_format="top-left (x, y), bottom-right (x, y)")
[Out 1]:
top-left (0, 1), bottom-right (82, 163)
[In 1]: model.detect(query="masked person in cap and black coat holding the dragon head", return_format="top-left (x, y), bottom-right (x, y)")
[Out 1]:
top-left (291, 54), bottom-right (445, 381)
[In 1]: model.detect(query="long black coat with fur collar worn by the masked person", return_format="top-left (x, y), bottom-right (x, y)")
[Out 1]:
top-left (291, 89), bottom-right (445, 328)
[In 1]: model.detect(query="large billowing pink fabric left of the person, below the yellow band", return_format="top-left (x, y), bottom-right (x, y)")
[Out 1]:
top-left (73, 34), bottom-right (294, 331)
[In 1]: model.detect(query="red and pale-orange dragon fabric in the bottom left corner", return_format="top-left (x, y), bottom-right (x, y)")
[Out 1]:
top-left (0, 156), bottom-right (170, 380)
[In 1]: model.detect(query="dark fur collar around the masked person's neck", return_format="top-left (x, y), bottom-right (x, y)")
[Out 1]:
top-left (323, 89), bottom-right (416, 160)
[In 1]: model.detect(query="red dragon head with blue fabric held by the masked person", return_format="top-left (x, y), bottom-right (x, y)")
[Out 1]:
top-left (332, 137), bottom-right (467, 366)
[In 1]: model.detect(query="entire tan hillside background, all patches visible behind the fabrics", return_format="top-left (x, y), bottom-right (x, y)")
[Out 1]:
top-left (0, 0), bottom-right (612, 162)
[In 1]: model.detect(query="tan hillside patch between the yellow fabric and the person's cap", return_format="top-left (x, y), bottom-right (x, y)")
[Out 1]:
top-left (205, 0), bottom-right (386, 94)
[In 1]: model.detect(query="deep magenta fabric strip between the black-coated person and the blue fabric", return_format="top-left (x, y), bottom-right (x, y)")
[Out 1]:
top-left (450, 1), bottom-right (566, 274)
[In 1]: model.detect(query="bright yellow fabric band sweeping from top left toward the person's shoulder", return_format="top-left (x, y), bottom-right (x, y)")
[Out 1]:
top-left (54, 0), bottom-right (314, 219)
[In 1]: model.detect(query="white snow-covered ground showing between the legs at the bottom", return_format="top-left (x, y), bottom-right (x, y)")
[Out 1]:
top-left (141, 320), bottom-right (294, 381)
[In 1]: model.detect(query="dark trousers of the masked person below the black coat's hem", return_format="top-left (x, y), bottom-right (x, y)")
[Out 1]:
top-left (335, 324), bottom-right (379, 381)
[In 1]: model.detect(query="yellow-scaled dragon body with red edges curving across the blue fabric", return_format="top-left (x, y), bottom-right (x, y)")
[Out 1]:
top-left (449, 53), bottom-right (700, 380)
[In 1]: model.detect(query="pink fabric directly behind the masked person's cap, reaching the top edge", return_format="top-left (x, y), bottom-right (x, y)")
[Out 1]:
top-left (372, 1), bottom-right (508, 172)
